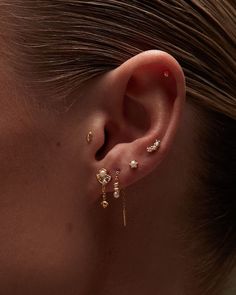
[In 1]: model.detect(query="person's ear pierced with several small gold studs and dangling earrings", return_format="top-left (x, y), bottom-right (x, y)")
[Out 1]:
top-left (87, 50), bottom-right (185, 199)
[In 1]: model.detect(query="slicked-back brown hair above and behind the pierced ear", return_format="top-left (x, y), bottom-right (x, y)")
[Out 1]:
top-left (0, 0), bottom-right (236, 294)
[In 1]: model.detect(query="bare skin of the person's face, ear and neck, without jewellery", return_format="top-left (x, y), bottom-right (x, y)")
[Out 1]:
top-left (0, 50), bottom-right (201, 295)
